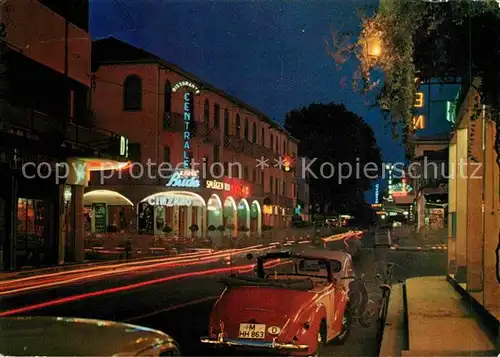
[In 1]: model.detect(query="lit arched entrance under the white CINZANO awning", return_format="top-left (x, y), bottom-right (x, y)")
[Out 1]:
top-left (137, 191), bottom-right (206, 237)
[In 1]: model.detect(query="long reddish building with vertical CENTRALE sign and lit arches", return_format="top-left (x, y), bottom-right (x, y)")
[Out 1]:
top-left (86, 38), bottom-right (297, 237)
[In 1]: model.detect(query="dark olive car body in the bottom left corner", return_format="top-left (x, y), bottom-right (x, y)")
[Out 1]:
top-left (0, 317), bottom-right (175, 356)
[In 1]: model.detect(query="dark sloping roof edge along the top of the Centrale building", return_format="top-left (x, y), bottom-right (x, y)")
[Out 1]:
top-left (92, 36), bottom-right (299, 142)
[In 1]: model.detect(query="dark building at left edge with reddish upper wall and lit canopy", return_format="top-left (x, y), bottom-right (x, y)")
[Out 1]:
top-left (0, 0), bottom-right (126, 270)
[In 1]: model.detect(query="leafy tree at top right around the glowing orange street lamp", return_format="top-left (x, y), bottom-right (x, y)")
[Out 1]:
top-left (329, 0), bottom-right (500, 161)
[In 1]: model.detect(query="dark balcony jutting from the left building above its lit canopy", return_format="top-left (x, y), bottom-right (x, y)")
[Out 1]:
top-left (2, 106), bottom-right (127, 159)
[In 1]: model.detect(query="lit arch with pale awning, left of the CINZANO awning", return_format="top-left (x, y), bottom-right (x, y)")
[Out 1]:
top-left (83, 190), bottom-right (135, 233)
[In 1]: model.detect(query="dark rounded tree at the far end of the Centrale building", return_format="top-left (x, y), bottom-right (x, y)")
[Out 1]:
top-left (285, 103), bottom-right (381, 214)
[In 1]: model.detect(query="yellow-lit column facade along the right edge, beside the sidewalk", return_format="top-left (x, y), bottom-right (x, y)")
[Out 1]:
top-left (448, 80), bottom-right (500, 319)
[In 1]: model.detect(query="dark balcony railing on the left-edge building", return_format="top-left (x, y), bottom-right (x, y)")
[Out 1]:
top-left (6, 106), bottom-right (126, 158)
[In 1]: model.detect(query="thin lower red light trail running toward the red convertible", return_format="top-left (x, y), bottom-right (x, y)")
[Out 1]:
top-left (0, 259), bottom-right (290, 317)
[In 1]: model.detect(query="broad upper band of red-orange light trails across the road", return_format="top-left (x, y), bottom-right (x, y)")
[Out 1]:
top-left (0, 244), bottom-right (269, 296)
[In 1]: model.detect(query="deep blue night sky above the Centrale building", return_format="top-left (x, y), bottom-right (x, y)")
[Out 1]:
top-left (90, 0), bottom-right (404, 202)
